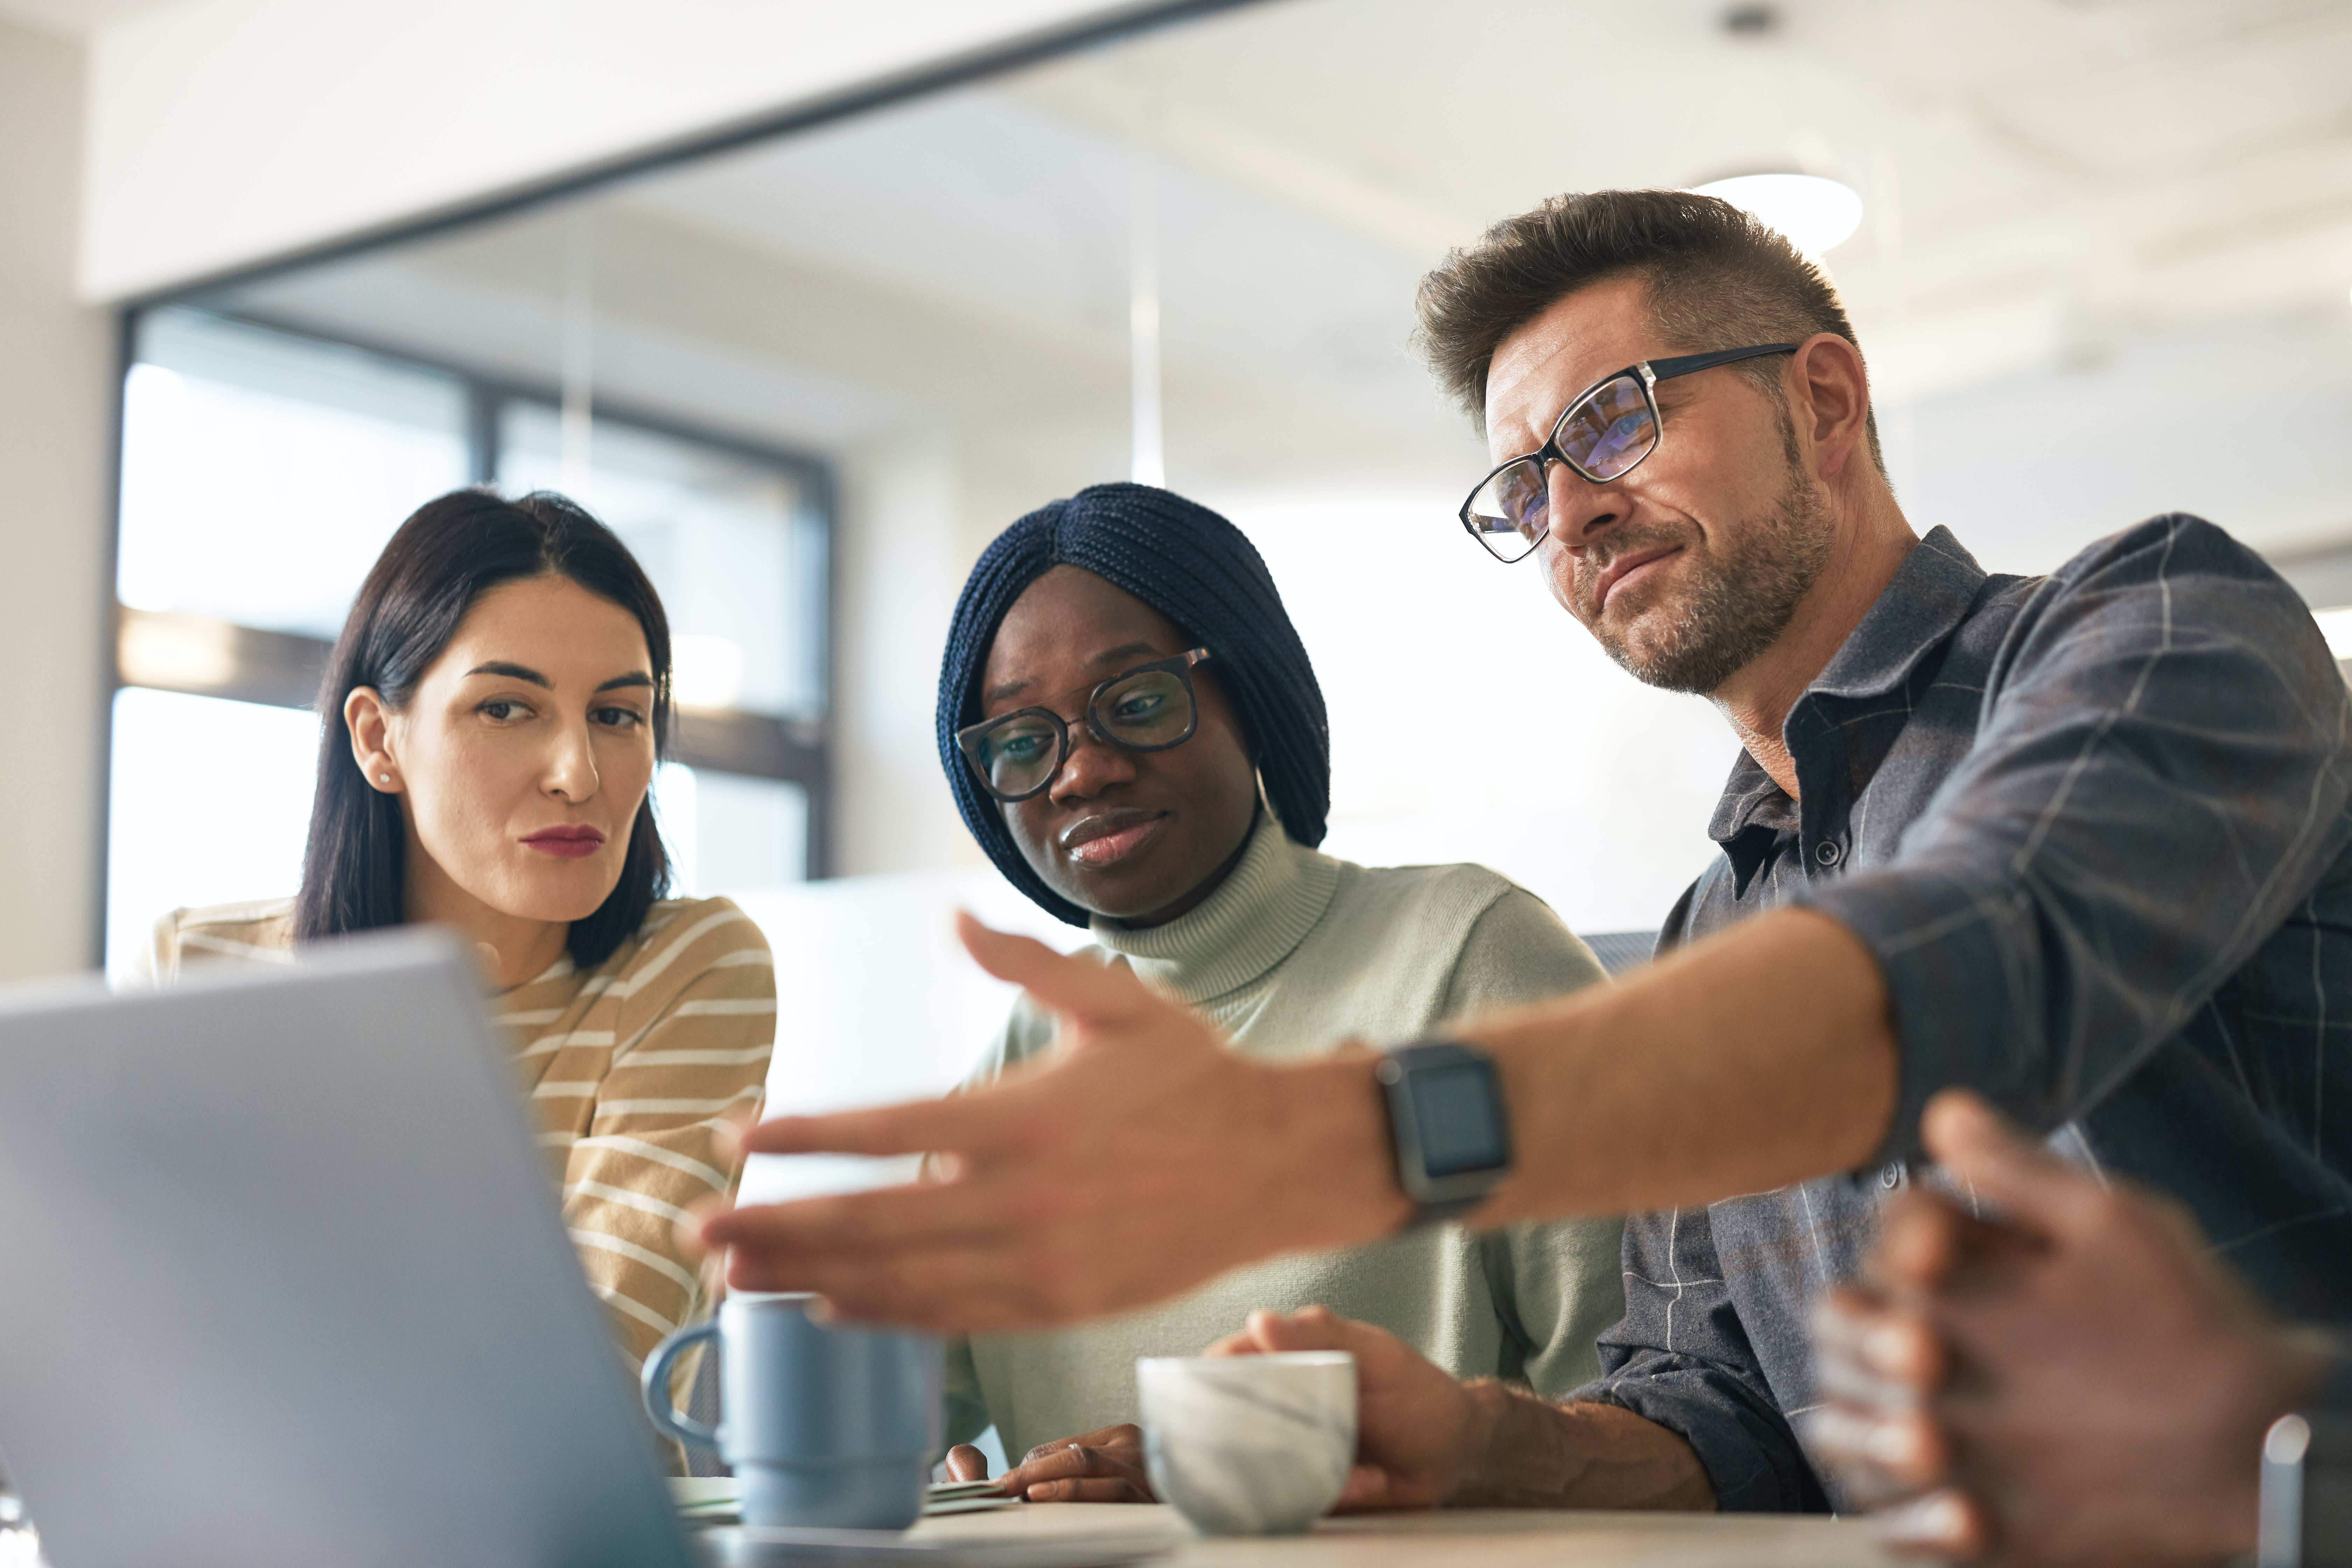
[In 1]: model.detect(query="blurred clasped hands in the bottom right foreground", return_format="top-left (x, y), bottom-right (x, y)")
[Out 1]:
top-left (1806, 1091), bottom-right (2324, 1566)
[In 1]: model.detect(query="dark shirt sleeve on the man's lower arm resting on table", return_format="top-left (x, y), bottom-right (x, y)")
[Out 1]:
top-left (1571, 1208), bottom-right (1830, 1514)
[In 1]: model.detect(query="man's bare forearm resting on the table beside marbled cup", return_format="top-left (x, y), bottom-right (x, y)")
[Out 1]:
top-left (1447, 1378), bottom-right (1715, 1509)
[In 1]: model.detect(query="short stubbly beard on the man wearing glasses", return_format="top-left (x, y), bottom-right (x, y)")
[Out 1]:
top-left (1585, 468), bottom-right (1835, 696)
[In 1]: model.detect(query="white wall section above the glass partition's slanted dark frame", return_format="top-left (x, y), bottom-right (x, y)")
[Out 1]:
top-left (80, 0), bottom-right (1185, 299)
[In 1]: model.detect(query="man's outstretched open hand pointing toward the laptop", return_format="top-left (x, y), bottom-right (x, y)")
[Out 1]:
top-left (685, 915), bottom-right (1409, 1333)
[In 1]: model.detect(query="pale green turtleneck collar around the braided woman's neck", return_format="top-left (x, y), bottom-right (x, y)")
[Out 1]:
top-left (1094, 811), bottom-right (1340, 1004)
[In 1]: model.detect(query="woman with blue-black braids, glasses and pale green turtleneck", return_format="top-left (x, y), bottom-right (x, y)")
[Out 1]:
top-left (938, 484), bottom-right (1625, 1500)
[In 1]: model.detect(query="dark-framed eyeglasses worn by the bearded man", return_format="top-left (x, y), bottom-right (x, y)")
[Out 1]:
top-left (1461, 343), bottom-right (1804, 562)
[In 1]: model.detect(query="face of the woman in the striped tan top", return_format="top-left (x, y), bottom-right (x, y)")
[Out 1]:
top-left (346, 576), bottom-right (654, 940)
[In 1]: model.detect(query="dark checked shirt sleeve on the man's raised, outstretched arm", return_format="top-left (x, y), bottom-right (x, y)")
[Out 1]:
top-left (1797, 517), bottom-right (2352, 1159)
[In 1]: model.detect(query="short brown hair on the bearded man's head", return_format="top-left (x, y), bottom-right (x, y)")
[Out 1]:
top-left (1414, 190), bottom-right (1886, 472)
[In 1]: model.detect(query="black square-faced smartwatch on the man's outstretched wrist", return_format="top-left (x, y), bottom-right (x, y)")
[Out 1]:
top-left (1373, 1039), bottom-right (1510, 1225)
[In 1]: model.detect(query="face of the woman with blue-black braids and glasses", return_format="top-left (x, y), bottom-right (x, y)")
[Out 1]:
top-left (981, 567), bottom-right (1258, 924)
